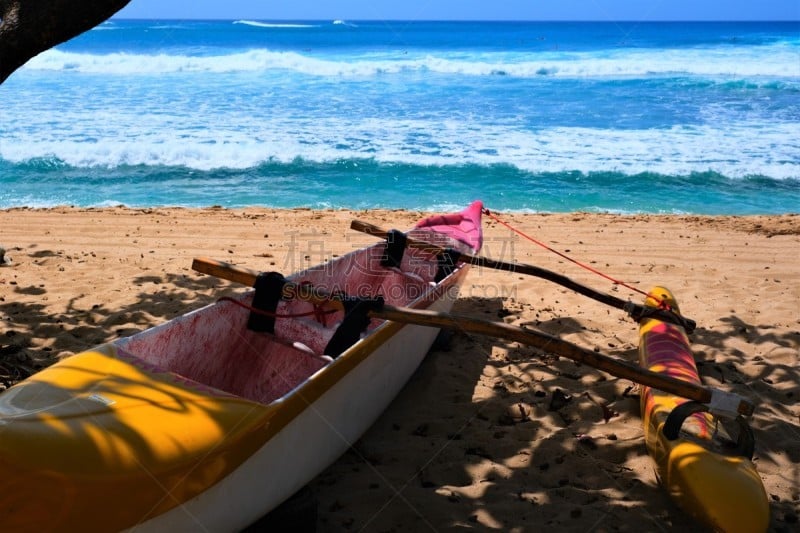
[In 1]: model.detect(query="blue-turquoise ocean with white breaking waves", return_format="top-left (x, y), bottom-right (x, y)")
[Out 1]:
top-left (0, 20), bottom-right (800, 215)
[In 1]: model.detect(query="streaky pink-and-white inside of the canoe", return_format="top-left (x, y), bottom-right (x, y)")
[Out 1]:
top-left (117, 211), bottom-right (480, 403)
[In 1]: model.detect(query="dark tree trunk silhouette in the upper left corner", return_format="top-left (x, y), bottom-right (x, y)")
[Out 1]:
top-left (0, 0), bottom-right (130, 83)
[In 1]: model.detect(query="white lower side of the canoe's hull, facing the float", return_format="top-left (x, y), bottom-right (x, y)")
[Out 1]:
top-left (133, 265), bottom-right (469, 532)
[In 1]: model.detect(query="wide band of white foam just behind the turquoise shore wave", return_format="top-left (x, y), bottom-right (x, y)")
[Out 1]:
top-left (0, 113), bottom-right (800, 179)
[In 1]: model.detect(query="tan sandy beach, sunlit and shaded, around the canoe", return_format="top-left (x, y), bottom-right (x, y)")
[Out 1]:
top-left (0, 207), bottom-right (800, 532)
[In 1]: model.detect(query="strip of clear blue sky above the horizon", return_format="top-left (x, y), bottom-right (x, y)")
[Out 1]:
top-left (117, 0), bottom-right (800, 21)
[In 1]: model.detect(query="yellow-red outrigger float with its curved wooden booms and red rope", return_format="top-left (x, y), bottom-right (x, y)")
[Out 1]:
top-left (351, 212), bottom-right (769, 533)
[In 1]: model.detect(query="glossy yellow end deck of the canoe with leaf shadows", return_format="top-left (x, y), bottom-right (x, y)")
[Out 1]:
top-left (0, 345), bottom-right (272, 531)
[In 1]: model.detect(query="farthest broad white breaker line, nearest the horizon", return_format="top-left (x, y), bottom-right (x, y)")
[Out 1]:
top-left (24, 45), bottom-right (800, 79)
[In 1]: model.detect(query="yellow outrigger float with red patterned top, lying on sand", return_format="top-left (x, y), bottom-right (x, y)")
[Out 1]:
top-left (639, 287), bottom-right (769, 533)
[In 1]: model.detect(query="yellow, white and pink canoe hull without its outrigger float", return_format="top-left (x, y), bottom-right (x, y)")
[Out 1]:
top-left (0, 202), bottom-right (482, 531)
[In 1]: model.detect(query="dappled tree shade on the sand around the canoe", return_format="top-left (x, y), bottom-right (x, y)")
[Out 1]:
top-left (0, 275), bottom-right (800, 532)
